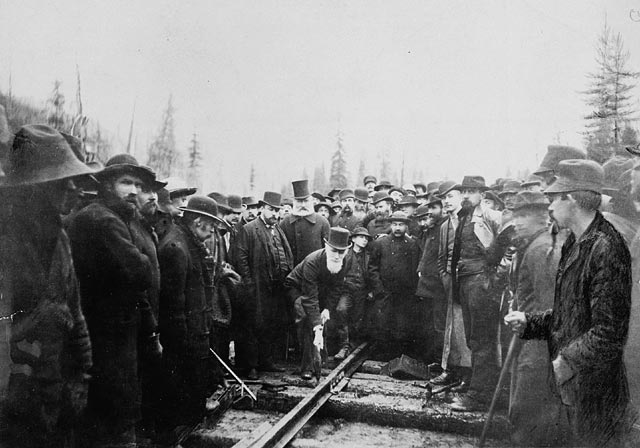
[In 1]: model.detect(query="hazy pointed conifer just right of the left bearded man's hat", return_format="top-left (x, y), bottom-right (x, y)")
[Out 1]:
top-left (147, 96), bottom-right (180, 179)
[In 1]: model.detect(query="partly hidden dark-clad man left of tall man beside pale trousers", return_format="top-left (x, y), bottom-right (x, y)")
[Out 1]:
top-left (416, 194), bottom-right (447, 363)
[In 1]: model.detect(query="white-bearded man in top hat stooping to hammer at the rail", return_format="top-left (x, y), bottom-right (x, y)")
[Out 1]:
top-left (285, 227), bottom-right (361, 380)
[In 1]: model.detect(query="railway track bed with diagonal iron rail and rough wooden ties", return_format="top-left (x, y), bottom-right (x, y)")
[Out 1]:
top-left (182, 343), bottom-right (509, 448)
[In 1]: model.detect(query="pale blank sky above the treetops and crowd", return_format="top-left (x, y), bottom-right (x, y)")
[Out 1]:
top-left (0, 0), bottom-right (640, 194)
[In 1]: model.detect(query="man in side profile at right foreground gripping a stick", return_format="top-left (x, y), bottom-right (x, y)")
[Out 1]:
top-left (505, 160), bottom-right (631, 447)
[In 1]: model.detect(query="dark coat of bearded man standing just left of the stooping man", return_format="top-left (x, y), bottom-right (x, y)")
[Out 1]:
top-left (236, 218), bottom-right (296, 326)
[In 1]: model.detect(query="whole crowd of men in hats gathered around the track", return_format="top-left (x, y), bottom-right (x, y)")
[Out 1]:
top-left (0, 125), bottom-right (640, 447)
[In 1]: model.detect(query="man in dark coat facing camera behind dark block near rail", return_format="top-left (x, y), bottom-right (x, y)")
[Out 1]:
top-left (370, 212), bottom-right (424, 356)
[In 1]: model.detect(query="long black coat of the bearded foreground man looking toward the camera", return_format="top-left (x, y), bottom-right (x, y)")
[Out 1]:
top-left (69, 199), bottom-right (156, 431)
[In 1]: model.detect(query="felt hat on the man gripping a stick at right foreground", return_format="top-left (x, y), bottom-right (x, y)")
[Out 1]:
top-left (544, 159), bottom-right (604, 193)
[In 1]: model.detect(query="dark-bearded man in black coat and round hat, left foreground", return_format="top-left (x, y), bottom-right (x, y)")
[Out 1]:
top-left (69, 154), bottom-right (160, 445)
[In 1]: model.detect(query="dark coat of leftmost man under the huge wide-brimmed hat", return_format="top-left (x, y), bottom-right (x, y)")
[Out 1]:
top-left (0, 209), bottom-right (91, 446)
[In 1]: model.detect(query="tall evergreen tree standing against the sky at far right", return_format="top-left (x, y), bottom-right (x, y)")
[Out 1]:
top-left (583, 23), bottom-right (639, 163)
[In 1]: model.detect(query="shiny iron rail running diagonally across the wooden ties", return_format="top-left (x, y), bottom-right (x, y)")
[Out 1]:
top-left (233, 342), bottom-right (370, 448)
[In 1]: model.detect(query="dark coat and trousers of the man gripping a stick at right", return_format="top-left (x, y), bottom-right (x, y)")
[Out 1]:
top-left (523, 212), bottom-right (631, 446)
